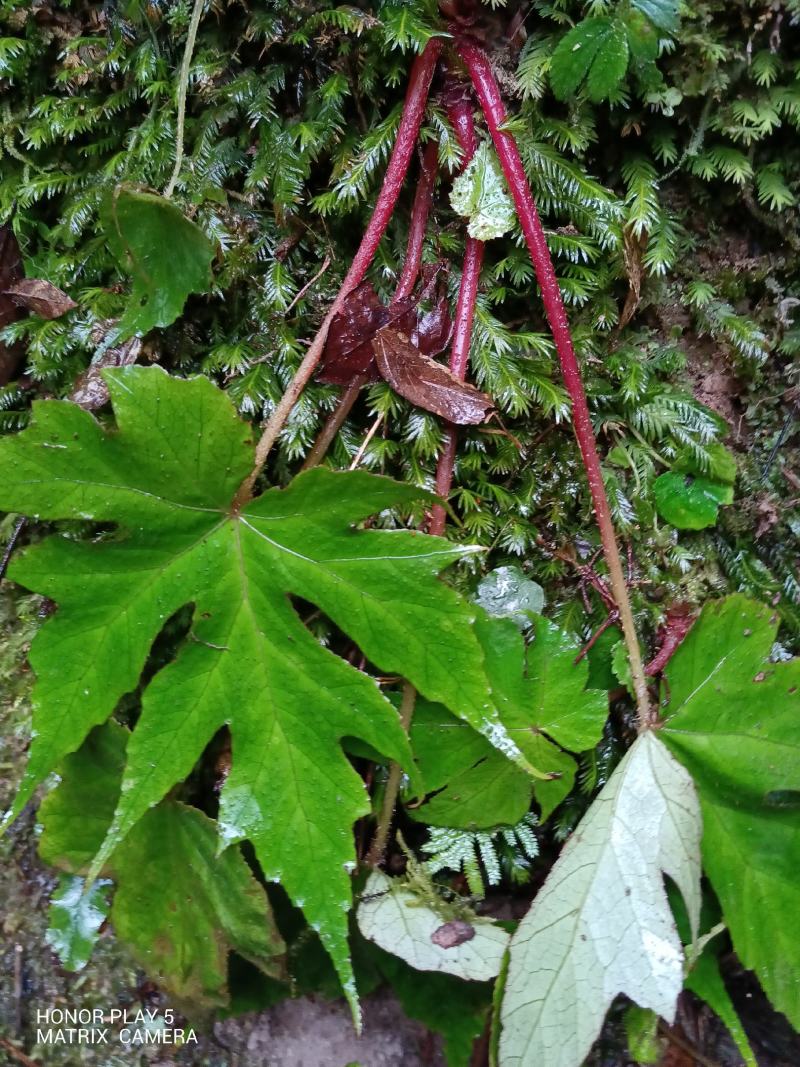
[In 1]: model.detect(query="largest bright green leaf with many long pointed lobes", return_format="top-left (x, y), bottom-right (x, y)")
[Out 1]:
top-left (0, 367), bottom-right (524, 996)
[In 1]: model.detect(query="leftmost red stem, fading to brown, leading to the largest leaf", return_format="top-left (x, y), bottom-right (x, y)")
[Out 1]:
top-left (235, 37), bottom-right (443, 507)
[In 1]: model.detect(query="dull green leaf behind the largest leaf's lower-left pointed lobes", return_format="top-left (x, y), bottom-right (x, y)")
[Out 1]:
top-left (39, 722), bottom-right (284, 1012)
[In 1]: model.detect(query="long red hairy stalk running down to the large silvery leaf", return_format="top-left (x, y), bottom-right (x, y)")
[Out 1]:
top-left (458, 37), bottom-right (654, 730)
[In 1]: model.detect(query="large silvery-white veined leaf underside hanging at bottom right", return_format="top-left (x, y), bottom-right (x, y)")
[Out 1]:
top-left (498, 732), bottom-right (702, 1067)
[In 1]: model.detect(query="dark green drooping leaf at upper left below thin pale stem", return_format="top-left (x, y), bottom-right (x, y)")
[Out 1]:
top-left (100, 188), bottom-right (214, 338)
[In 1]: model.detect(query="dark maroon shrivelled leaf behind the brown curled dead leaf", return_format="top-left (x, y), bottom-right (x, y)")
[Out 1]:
top-left (318, 282), bottom-right (416, 385)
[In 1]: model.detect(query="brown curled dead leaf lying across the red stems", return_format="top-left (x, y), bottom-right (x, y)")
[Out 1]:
top-left (372, 327), bottom-right (494, 426)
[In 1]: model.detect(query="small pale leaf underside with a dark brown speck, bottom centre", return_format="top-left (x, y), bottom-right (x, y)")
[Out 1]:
top-left (356, 871), bottom-right (509, 982)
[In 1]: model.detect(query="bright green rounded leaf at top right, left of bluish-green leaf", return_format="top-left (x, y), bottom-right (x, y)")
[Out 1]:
top-left (550, 15), bottom-right (628, 101)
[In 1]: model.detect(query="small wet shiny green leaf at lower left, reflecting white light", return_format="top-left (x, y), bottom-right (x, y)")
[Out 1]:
top-left (45, 875), bottom-right (109, 971)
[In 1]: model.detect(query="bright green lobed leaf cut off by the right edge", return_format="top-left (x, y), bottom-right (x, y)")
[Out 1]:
top-left (659, 595), bottom-right (800, 1026)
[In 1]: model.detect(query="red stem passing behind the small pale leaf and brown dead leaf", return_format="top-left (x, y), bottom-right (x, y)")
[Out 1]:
top-left (428, 91), bottom-right (484, 537)
